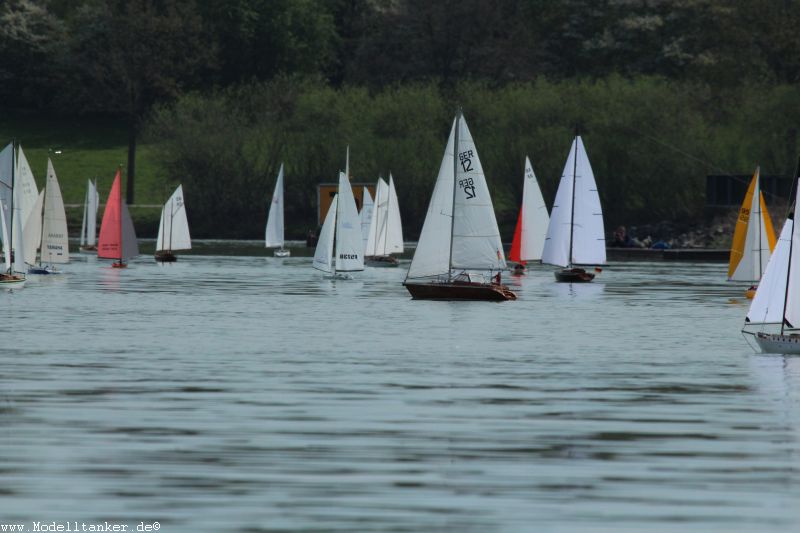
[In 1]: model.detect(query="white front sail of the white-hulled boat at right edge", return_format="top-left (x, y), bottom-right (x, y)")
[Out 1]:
top-left (747, 219), bottom-right (796, 324)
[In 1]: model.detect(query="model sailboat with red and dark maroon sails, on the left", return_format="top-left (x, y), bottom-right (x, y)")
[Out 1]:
top-left (97, 169), bottom-right (139, 268)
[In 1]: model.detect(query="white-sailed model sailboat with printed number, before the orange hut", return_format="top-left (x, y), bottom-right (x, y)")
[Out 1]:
top-left (313, 172), bottom-right (364, 279)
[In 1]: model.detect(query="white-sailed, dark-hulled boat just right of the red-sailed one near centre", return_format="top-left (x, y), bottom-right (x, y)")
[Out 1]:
top-left (542, 135), bottom-right (606, 283)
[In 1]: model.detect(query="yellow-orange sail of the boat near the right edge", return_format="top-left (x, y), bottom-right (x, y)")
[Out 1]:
top-left (728, 167), bottom-right (775, 281)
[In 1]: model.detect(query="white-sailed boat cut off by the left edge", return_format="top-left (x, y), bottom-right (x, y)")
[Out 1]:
top-left (0, 142), bottom-right (25, 288)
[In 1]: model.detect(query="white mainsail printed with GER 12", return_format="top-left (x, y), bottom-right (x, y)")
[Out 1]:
top-left (451, 112), bottom-right (506, 270)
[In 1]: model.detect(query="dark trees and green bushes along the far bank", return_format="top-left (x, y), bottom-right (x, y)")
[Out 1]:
top-left (0, 0), bottom-right (800, 237)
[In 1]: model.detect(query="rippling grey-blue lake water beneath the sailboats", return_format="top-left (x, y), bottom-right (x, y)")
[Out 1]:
top-left (0, 244), bottom-right (800, 533)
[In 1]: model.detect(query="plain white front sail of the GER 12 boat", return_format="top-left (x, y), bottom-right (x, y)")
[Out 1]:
top-left (408, 118), bottom-right (458, 279)
